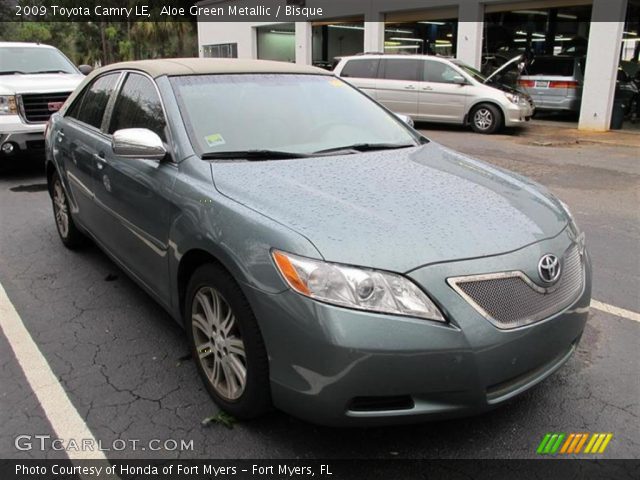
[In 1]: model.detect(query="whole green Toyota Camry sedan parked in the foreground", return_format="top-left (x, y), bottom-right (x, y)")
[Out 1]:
top-left (46, 59), bottom-right (591, 425)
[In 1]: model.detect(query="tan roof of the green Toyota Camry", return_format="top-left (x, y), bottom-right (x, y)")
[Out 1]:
top-left (95, 58), bottom-right (332, 78)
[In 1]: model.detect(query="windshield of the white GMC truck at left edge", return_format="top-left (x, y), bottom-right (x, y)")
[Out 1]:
top-left (0, 47), bottom-right (78, 75)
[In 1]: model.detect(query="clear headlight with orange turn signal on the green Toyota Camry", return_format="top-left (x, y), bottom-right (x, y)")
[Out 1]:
top-left (272, 250), bottom-right (445, 322)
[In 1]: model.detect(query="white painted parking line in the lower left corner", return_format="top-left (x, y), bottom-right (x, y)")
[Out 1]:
top-left (0, 284), bottom-right (106, 460)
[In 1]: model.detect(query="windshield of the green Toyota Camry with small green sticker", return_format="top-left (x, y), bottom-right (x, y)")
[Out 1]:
top-left (171, 74), bottom-right (419, 156)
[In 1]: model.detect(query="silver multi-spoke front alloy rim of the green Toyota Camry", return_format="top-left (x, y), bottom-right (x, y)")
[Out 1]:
top-left (191, 287), bottom-right (247, 400)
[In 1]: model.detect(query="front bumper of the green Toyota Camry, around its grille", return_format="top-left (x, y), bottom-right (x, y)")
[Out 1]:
top-left (247, 233), bottom-right (591, 426)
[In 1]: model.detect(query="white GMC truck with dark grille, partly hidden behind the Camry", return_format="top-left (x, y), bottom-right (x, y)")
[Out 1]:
top-left (0, 42), bottom-right (90, 163)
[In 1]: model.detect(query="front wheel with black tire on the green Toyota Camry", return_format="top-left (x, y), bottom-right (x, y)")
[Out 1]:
top-left (184, 264), bottom-right (271, 419)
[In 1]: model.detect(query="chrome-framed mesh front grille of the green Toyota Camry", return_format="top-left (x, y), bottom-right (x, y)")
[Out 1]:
top-left (449, 244), bottom-right (584, 329)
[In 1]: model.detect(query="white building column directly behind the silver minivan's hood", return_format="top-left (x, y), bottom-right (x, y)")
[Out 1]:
top-left (456, 0), bottom-right (484, 70)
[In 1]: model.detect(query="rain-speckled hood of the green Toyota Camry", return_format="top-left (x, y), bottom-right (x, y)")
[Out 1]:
top-left (212, 142), bottom-right (567, 272)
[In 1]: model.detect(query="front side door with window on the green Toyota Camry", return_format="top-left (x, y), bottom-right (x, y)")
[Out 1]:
top-left (90, 73), bottom-right (177, 299)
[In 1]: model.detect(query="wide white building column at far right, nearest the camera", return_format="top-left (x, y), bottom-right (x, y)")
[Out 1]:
top-left (578, 0), bottom-right (627, 132)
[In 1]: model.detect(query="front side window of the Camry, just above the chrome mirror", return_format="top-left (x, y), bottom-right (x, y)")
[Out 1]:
top-left (109, 73), bottom-right (166, 141)
